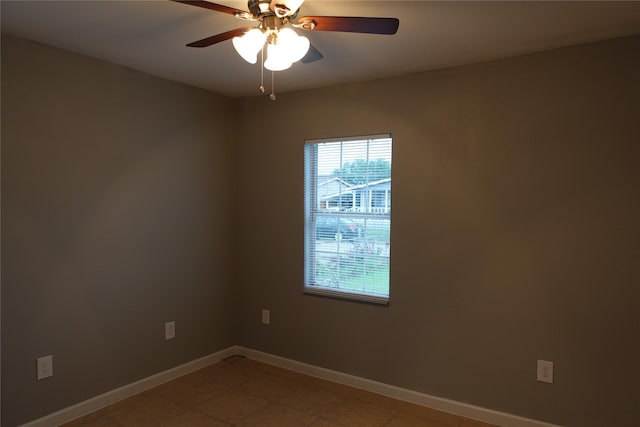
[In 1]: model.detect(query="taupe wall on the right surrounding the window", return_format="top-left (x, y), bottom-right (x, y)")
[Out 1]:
top-left (235, 37), bottom-right (640, 427)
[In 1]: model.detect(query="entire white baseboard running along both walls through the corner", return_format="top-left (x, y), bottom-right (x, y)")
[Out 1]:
top-left (22, 346), bottom-right (560, 427)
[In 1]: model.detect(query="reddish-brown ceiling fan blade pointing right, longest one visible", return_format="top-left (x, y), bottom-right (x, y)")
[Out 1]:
top-left (296, 16), bottom-right (400, 35)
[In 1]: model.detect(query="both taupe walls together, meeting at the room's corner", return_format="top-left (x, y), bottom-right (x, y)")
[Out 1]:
top-left (2, 32), bottom-right (640, 427)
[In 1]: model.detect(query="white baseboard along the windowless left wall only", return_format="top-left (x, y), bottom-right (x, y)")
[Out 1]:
top-left (21, 347), bottom-right (238, 427)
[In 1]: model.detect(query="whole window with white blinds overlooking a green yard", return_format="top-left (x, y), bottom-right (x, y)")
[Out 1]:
top-left (304, 135), bottom-right (392, 304)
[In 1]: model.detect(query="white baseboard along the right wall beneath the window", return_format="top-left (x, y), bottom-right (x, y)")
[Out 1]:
top-left (236, 346), bottom-right (560, 427)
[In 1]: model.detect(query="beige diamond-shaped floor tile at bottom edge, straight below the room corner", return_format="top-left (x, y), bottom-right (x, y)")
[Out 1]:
top-left (196, 390), bottom-right (269, 424)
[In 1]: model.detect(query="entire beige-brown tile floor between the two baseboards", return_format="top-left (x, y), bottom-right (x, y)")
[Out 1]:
top-left (64, 357), bottom-right (498, 427)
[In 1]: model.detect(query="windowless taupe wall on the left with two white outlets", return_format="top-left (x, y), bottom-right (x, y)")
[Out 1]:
top-left (2, 35), bottom-right (234, 427)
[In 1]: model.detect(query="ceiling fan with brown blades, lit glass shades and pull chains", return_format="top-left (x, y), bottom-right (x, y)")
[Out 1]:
top-left (173, 0), bottom-right (400, 100)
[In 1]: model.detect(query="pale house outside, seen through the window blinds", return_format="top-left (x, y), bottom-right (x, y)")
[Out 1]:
top-left (318, 178), bottom-right (391, 214)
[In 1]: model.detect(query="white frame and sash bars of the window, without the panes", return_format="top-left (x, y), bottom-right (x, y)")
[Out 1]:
top-left (303, 133), bottom-right (393, 306)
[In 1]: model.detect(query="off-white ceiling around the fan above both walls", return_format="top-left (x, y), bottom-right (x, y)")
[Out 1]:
top-left (0, 0), bottom-right (640, 97)
